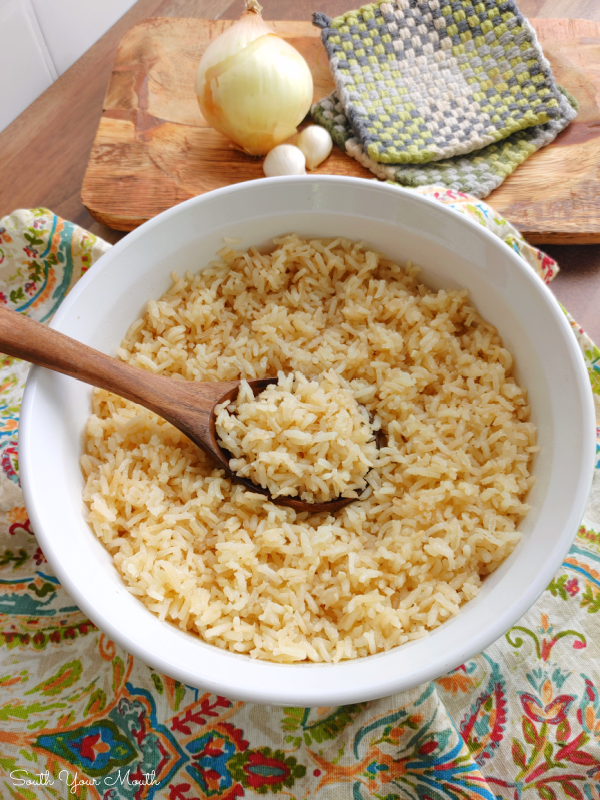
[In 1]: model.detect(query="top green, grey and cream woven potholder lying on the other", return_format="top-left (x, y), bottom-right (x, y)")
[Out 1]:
top-left (313, 0), bottom-right (575, 164)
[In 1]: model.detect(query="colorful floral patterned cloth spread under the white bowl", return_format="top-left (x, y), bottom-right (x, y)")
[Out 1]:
top-left (0, 195), bottom-right (600, 800)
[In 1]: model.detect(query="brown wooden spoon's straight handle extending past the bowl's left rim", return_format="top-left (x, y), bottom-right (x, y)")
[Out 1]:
top-left (0, 306), bottom-right (195, 417)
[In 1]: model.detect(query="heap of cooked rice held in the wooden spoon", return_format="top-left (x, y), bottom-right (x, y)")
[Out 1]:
top-left (215, 370), bottom-right (377, 503)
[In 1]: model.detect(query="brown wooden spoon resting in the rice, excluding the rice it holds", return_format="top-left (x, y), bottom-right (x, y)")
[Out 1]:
top-left (0, 306), bottom-right (356, 514)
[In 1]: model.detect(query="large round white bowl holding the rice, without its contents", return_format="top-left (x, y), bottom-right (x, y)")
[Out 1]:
top-left (19, 176), bottom-right (595, 706)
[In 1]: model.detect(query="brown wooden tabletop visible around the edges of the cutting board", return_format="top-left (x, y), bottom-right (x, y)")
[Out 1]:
top-left (0, 0), bottom-right (600, 342)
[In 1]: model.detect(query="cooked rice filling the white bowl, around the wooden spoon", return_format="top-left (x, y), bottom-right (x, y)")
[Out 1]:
top-left (82, 235), bottom-right (537, 662)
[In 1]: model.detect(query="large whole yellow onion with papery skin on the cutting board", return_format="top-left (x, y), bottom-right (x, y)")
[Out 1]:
top-left (196, 0), bottom-right (313, 155)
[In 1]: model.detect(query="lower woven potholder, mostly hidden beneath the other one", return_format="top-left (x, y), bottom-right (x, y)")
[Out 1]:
top-left (312, 87), bottom-right (577, 198)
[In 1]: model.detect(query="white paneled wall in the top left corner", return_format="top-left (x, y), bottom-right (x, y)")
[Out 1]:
top-left (0, 0), bottom-right (136, 131)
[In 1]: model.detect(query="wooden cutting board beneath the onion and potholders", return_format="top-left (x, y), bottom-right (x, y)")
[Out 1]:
top-left (82, 18), bottom-right (600, 244)
